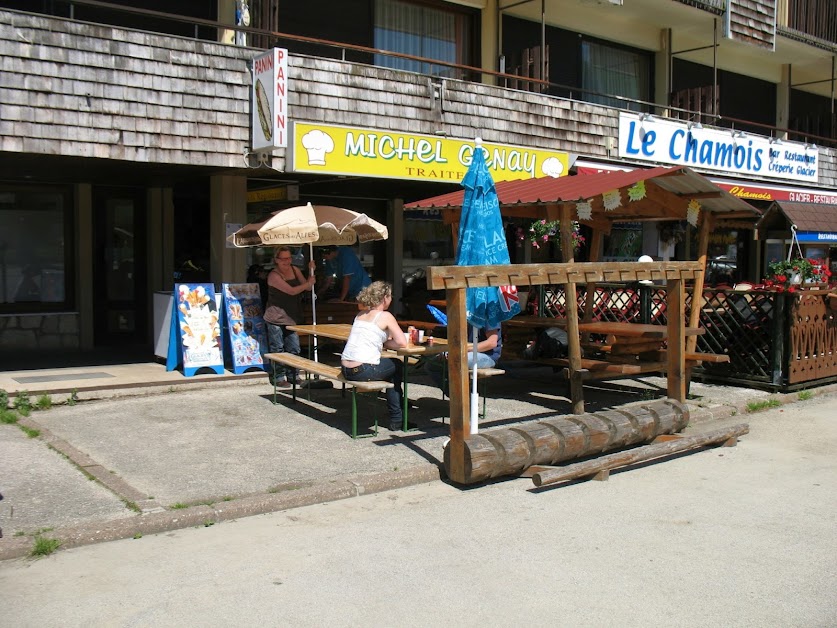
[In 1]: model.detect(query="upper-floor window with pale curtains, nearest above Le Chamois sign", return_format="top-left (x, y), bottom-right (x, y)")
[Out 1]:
top-left (581, 41), bottom-right (652, 111)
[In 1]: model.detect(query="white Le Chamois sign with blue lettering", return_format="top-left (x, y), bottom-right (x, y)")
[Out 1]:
top-left (619, 113), bottom-right (819, 183)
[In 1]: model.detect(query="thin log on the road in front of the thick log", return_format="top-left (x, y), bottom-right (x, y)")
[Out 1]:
top-left (532, 423), bottom-right (750, 486)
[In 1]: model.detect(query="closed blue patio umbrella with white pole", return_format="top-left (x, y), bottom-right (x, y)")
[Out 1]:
top-left (456, 138), bottom-right (520, 434)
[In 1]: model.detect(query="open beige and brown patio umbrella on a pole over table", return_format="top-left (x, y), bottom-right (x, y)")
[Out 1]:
top-left (227, 203), bottom-right (389, 360)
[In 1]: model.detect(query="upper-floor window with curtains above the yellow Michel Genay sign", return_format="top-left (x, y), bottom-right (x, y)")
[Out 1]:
top-left (375, 0), bottom-right (471, 77)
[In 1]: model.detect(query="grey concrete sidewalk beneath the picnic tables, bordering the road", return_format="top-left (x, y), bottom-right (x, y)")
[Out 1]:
top-left (0, 363), bottom-right (837, 559)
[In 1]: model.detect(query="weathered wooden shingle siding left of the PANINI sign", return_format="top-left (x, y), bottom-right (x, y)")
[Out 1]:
top-left (0, 11), bottom-right (254, 168)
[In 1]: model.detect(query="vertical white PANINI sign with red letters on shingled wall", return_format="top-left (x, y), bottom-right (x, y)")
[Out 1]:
top-left (250, 48), bottom-right (288, 152)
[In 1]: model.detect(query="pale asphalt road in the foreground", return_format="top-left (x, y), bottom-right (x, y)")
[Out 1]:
top-left (0, 396), bottom-right (837, 628)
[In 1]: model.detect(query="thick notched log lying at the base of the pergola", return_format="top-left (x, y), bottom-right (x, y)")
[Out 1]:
top-left (444, 399), bottom-right (689, 484)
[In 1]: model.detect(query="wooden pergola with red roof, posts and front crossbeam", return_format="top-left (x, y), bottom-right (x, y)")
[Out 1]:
top-left (405, 167), bottom-right (758, 481)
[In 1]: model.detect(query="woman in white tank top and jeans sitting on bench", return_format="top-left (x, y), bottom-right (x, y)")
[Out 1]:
top-left (340, 281), bottom-right (407, 431)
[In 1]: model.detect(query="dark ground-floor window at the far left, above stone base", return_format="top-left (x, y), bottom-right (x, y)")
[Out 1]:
top-left (0, 185), bottom-right (73, 312)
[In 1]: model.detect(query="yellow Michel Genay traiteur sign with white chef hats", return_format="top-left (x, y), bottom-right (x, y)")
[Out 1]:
top-left (288, 122), bottom-right (570, 182)
